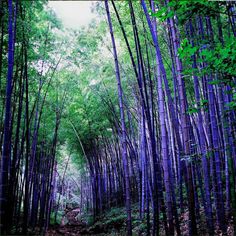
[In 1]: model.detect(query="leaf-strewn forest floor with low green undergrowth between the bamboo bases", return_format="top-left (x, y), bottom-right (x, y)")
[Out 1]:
top-left (46, 208), bottom-right (234, 236)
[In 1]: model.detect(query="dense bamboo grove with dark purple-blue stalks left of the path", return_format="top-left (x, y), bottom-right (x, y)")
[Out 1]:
top-left (0, 1), bottom-right (66, 234)
